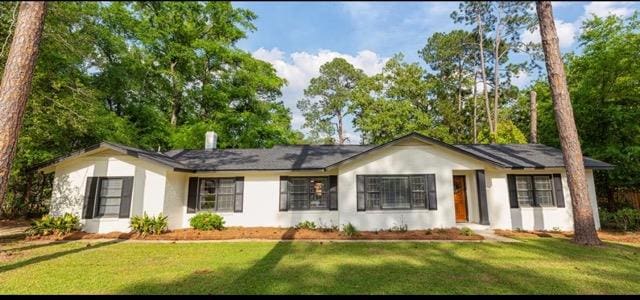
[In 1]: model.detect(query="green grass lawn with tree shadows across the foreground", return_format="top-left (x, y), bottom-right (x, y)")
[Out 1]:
top-left (0, 238), bottom-right (640, 294)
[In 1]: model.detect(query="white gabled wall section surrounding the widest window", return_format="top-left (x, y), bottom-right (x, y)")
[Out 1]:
top-left (338, 144), bottom-right (484, 230)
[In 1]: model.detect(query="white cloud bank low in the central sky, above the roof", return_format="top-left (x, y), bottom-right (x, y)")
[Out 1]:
top-left (252, 48), bottom-right (389, 143)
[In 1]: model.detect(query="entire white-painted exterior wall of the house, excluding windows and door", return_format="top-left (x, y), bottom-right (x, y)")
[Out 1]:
top-left (51, 141), bottom-right (599, 233)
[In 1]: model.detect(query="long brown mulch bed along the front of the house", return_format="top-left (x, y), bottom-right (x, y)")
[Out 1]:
top-left (27, 227), bottom-right (483, 240)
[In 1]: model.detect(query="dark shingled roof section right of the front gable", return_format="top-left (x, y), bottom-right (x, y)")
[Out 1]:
top-left (454, 144), bottom-right (613, 169)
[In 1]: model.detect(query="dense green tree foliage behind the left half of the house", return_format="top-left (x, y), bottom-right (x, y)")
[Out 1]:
top-left (0, 2), bottom-right (300, 216)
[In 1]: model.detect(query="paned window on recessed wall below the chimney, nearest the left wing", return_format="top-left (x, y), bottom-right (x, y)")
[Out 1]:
top-left (198, 178), bottom-right (236, 211)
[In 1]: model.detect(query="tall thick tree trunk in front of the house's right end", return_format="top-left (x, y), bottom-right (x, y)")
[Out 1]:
top-left (536, 1), bottom-right (601, 245)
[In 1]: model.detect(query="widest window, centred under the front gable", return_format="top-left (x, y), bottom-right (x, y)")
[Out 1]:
top-left (364, 175), bottom-right (427, 209)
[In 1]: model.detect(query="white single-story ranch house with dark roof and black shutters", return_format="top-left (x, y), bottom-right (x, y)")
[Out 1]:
top-left (39, 133), bottom-right (612, 233)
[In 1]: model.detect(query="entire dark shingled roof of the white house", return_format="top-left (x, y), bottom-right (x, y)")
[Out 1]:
top-left (36, 133), bottom-right (613, 172)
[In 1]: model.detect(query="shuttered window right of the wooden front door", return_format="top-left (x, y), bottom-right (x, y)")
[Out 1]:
top-left (515, 175), bottom-right (555, 207)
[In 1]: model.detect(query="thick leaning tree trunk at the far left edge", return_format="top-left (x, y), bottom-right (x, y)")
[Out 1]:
top-left (0, 1), bottom-right (46, 209)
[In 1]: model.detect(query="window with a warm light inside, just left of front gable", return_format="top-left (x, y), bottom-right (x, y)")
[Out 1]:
top-left (287, 177), bottom-right (329, 210)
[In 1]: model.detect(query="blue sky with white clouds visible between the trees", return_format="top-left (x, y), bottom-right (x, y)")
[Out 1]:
top-left (233, 1), bottom-right (640, 143)
